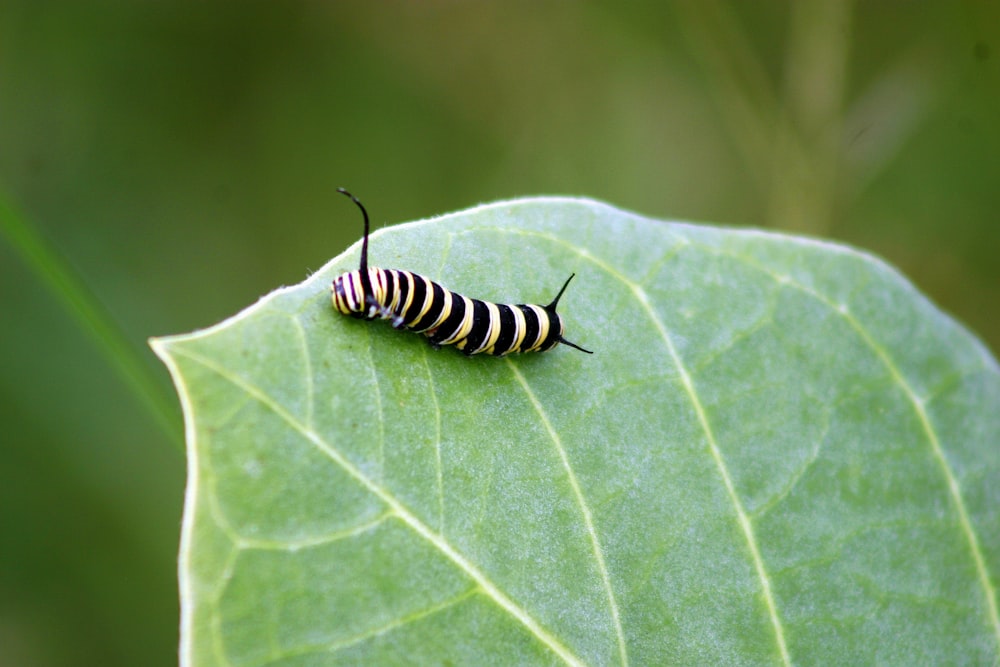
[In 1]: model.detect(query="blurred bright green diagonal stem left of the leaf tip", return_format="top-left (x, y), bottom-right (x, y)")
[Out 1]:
top-left (0, 193), bottom-right (184, 451)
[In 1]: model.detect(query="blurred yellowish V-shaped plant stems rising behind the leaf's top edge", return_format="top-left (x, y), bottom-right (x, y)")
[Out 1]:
top-left (677, 0), bottom-right (852, 235)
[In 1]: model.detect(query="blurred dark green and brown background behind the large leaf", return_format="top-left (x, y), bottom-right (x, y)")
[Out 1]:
top-left (0, 0), bottom-right (1000, 667)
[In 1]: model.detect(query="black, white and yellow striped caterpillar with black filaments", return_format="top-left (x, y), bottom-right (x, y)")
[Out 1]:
top-left (330, 188), bottom-right (593, 357)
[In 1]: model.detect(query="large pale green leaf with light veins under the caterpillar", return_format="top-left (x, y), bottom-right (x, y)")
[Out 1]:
top-left (153, 199), bottom-right (1000, 666)
